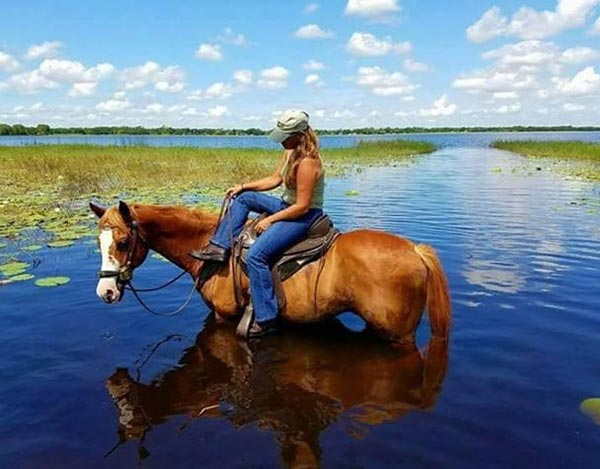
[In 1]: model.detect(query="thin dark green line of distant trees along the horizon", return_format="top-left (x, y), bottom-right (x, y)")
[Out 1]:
top-left (0, 124), bottom-right (600, 136)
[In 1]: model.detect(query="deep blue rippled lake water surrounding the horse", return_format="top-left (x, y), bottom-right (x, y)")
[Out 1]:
top-left (0, 133), bottom-right (600, 468)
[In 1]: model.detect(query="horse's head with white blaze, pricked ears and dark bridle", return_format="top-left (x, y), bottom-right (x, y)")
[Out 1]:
top-left (90, 202), bottom-right (148, 303)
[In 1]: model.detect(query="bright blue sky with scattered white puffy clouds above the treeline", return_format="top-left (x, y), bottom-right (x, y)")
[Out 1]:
top-left (0, 0), bottom-right (600, 129)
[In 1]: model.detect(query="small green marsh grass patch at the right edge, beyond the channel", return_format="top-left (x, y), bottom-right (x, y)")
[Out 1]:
top-left (491, 140), bottom-right (600, 181)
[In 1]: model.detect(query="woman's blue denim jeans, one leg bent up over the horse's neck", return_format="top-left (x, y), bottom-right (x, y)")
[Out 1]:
top-left (211, 192), bottom-right (323, 321)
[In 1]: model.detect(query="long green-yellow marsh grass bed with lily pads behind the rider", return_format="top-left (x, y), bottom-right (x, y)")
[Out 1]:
top-left (0, 141), bottom-right (435, 238)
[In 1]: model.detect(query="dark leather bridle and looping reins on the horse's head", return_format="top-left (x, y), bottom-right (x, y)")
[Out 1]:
top-left (98, 216), bottom-right (200, 316)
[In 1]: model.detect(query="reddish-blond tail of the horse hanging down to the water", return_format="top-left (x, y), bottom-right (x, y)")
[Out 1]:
top-left (415, 244), bottom-right (452, 339)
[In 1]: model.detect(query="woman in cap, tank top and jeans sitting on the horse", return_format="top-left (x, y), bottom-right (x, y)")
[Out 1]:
top-left (190, 111), bottom-right (324, 337)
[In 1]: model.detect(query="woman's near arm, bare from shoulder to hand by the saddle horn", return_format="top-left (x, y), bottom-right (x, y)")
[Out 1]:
top-left (256, 158), bottom-right (321, 233)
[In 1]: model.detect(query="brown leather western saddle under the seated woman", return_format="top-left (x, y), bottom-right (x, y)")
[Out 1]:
top-left (233, 214), bottom-right (340, 282)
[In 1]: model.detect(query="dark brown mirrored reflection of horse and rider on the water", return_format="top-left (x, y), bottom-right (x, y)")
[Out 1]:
top-left (107, 319), bottom-right (448, 467)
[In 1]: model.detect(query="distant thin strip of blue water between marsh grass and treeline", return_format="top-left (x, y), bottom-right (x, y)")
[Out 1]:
top-left (0, 132), bottom-right (600, 148)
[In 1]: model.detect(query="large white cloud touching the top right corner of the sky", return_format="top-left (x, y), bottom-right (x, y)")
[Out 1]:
top-left (467, 0), bottom-right (600, 42)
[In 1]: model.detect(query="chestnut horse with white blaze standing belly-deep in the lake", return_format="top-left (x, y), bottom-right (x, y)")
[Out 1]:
top-left (90, 202), bottom-right (451, 342)
